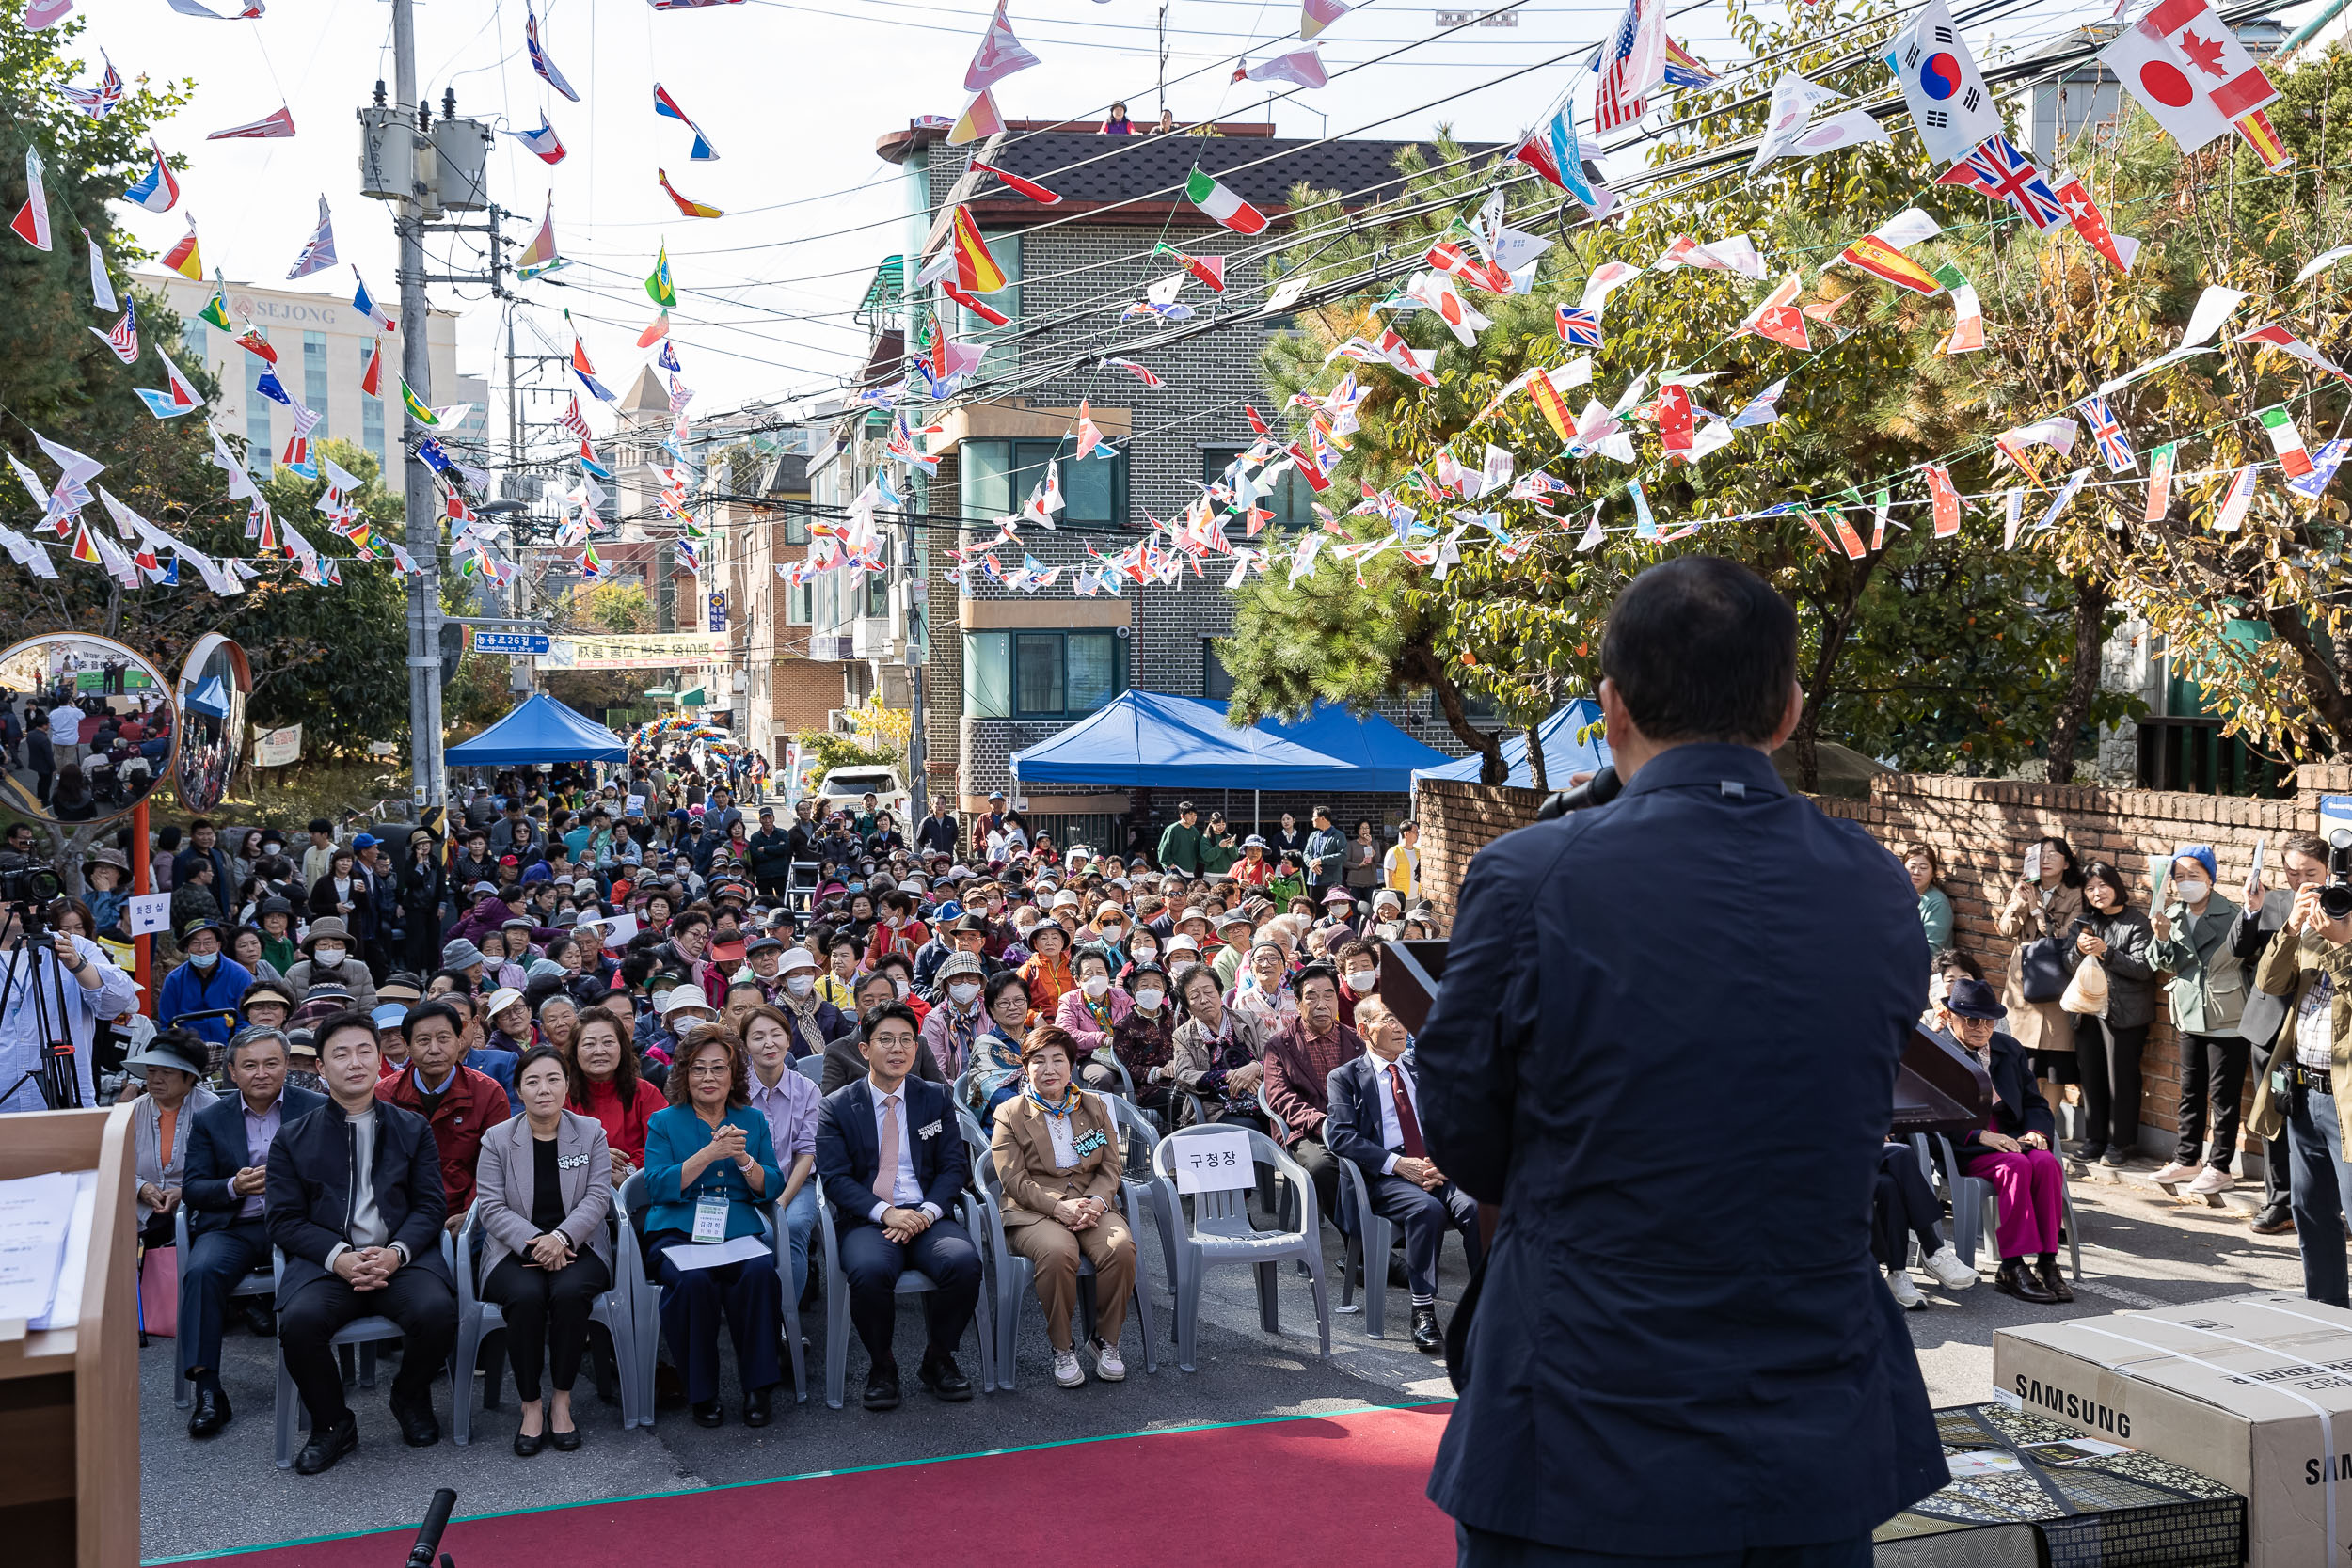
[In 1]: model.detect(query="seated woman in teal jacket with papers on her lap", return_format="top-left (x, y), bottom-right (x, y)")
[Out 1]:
top-left (644, 1025), bottom-right (784, 1427)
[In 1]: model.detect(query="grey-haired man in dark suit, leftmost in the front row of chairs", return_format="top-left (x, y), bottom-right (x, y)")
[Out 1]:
top-left (179, 1030), bottom-right (327, 1436)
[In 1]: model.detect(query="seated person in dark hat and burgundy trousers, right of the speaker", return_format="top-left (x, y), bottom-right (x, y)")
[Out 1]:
top-left (1943, 975), bottom-right (2074, 1305)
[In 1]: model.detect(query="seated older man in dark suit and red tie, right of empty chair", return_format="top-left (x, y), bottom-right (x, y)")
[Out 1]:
top-left (1325, 997), bottom-right (1480, 1356)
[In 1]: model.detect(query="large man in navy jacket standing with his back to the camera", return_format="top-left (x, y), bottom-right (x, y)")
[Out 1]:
top-left (1414, 555), bottom-right (1950, 1568)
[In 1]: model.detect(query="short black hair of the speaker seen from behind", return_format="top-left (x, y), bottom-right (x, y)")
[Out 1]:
top-left (1602, 555), bottom-right (1797, 745)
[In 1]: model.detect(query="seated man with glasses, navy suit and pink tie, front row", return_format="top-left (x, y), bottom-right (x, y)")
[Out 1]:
top-left (817, 1002), bottom-right (981, 1411)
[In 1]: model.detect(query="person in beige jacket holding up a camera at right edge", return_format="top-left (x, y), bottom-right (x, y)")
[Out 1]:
top-left (2247, 828), bottom-right (2352, 1307)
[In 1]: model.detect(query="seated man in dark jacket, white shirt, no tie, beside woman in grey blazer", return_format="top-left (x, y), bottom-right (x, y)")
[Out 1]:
top-left (263, 1013), bottom-right (456, 1477)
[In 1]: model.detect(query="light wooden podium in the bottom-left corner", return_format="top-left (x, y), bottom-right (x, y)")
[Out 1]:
top-left (0, 1105), bottom-right (139, 1568)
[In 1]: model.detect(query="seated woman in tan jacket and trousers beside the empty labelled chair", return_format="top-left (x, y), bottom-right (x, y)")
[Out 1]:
top-left (988, 1025), bottom-right (1136, 1389)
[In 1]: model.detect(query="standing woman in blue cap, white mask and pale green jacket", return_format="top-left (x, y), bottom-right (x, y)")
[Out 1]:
top-left (2148, 844), bottom-right (2249, 1196)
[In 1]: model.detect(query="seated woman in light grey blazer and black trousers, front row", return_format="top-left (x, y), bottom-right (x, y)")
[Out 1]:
top-left (475, 1046), bottom-right (612, 1458)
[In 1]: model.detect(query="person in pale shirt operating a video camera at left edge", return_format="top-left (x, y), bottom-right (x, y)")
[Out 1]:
top-left (0, 867), bottom-right (139, 1112)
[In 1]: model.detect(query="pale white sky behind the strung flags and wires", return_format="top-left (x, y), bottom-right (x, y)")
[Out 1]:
top-left (75, 0), bottom-right (2343, 451)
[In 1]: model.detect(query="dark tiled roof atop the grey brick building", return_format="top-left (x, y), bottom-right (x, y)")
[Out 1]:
top-left (977, 132), bottom-right (1489, 216)
